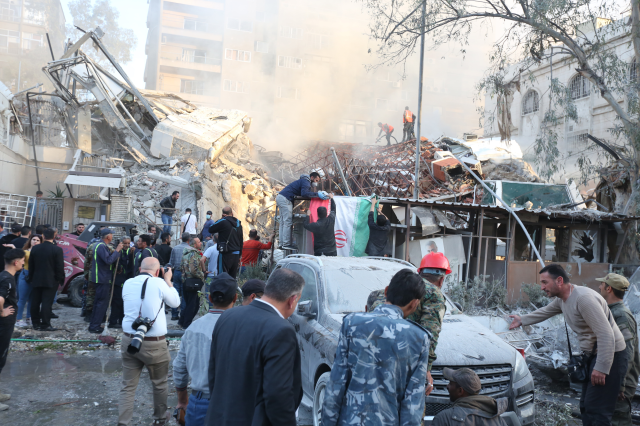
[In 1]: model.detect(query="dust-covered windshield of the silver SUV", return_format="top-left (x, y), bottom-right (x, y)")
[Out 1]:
top-left (325, 261), bottom-right (405, 314)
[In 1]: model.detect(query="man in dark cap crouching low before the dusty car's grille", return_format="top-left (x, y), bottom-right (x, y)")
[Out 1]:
top-left (432, 368), bottom-right (509, 426)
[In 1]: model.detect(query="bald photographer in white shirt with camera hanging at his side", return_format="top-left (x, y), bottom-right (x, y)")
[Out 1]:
top-left (118, 257), bottom-right (180, 425)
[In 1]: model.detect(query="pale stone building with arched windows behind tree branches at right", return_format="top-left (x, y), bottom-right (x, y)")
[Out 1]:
top-left (484, 22), bottom-right (637, 183)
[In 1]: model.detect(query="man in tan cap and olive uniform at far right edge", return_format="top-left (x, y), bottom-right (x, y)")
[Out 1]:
top-left (596, 274), bottom-right (640, 426)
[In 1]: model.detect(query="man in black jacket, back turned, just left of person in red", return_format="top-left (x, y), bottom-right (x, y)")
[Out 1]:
top-left (209, 206), bottom-right (243, 278)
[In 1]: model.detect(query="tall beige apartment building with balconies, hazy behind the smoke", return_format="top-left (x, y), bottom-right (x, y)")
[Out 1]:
top-left (145, 0), bottom-right (490, 148)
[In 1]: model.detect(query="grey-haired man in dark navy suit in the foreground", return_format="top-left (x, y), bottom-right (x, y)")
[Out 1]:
top-left (205, 269), bottom-right (304, 426)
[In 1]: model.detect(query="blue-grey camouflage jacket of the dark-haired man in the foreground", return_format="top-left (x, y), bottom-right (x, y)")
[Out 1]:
top-left (322, 305), bottom-right (429, 426)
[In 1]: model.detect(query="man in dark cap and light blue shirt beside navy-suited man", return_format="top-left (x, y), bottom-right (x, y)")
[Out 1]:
top-left (173, 272), bottom-right (238, 426)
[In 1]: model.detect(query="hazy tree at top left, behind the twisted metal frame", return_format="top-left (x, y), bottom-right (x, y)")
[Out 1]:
top-left (67, 0), bottom-right (138, 69)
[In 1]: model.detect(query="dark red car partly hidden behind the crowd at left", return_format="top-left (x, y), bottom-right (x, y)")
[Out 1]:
top-left (56, 222), bottom-right (137, 308)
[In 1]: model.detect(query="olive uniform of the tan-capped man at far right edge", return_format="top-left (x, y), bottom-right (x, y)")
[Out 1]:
top-left (609, 302), bottom-right (640, 426)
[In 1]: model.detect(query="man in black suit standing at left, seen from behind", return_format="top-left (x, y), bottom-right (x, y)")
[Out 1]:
top-left (27, 228), bottom-right (64, 331)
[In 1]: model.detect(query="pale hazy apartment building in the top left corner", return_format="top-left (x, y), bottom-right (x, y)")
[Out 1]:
top-left (0, 0), bottom-right (65, 92)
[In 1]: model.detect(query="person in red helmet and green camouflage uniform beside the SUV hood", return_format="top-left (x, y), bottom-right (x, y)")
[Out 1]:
top-left (367, 252), bottom-right (451, 395)
